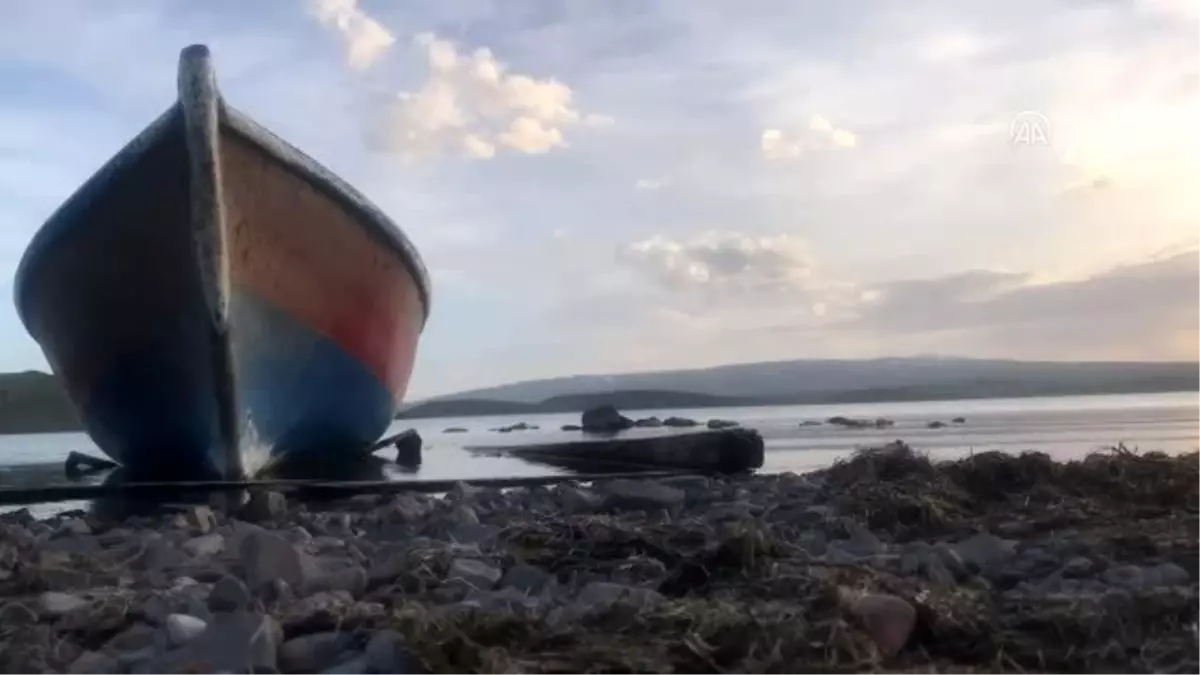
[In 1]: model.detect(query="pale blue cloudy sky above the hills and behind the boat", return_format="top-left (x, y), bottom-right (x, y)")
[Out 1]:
top-left (0, 0), bottom-right (1200, 398)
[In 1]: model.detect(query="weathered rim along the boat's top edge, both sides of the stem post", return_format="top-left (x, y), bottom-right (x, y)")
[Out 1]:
top-left (13, 48), bottom-right (432, 329)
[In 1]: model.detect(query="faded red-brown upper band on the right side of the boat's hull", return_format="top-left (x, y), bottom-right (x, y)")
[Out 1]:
top-left (221, 135), bottom-right (424, 400)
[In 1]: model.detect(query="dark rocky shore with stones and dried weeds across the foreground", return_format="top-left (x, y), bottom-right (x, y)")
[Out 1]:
top-left (0, 443), bottom-right (1200, 675)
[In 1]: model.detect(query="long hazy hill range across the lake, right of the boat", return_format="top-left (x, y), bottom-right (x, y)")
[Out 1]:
top-left (401, 357), bottom-right (1200, 418)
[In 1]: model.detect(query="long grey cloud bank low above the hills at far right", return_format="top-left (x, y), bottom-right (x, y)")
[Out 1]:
top-left (830, 250), bottom-right (1200, 359)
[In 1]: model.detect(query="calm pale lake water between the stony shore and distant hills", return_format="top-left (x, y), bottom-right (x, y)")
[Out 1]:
top-left (0, 393), bottom-right (1200, 485)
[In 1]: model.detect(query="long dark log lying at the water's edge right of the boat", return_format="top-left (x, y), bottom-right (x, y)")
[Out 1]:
top-left (468, 429), bottom-right (763, 473)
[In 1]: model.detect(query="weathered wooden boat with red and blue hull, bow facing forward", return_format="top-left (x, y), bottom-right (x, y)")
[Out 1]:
top-left (14, 46), bottom-right (430, 480)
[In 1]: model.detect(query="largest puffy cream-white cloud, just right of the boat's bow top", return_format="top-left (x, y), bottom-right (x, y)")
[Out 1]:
top-left (364, 32), bottom-right (612, 160)
